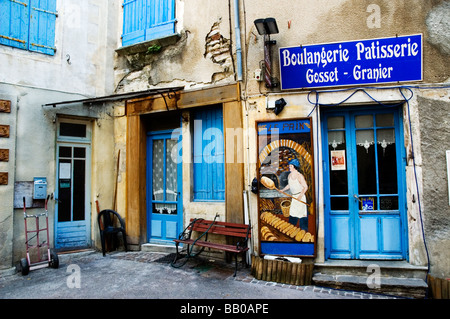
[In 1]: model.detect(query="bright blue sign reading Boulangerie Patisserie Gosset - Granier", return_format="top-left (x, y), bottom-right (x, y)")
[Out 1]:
top-left (279, 34), bottom-right (423, 90)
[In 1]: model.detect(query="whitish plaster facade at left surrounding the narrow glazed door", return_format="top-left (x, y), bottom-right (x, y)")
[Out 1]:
top-left (0, 0), bottom-right (120, 268)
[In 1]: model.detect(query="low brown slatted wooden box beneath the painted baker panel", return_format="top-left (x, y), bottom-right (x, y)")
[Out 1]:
top-left (251, 256), bottom-right (314, 286)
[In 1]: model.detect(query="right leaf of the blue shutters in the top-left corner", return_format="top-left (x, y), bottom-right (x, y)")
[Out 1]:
top-left (29, 0), bottom-right (58, 55)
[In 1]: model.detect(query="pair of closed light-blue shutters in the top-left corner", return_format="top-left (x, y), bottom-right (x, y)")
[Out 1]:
top-left (0, 0), bottom-right (58, 55)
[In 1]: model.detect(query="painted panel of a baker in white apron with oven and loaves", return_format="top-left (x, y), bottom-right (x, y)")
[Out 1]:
top-left (257, 118), bottom-right (317, 257)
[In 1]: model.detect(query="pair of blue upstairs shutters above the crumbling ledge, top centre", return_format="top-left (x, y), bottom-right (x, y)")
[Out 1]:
top-left (122, 0), bottom-right (175, 46)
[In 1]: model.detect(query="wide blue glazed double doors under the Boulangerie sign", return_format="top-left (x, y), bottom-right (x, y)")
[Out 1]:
top-left (322, 108), bottom-right (407, 259)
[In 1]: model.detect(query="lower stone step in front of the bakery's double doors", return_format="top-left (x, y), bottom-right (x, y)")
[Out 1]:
top-left (312, 273), bottom-right (428, 299)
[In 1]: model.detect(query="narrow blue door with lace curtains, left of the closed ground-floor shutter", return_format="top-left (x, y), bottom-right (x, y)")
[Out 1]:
top-left (147, 130), bottom-right (183, 244)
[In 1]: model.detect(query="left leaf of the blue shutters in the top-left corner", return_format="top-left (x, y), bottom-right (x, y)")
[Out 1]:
top-left (0, 0), bottom-right (30, 50)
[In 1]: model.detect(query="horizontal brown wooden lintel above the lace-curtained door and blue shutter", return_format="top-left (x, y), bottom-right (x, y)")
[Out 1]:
top-left (126, 83), bottom-right (240, 115)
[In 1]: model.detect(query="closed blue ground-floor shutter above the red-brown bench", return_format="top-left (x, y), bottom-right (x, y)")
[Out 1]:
top-left (193, 107), bottom-right (225, 201)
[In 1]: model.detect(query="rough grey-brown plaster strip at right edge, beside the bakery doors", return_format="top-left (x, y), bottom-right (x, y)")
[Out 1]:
top-left (418, 95), bottom-right (450, 278)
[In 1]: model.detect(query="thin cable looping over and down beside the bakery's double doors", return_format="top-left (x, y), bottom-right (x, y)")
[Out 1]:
top-left (307, 85), bottom-right (450, 281)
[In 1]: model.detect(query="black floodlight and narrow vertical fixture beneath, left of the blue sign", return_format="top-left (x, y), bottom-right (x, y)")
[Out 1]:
top-left (254, 18), bottom-right (278, 88)
